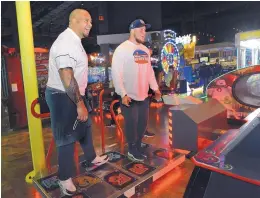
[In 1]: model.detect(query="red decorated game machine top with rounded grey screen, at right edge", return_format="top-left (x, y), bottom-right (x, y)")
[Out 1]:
top-left (207, 65), bottom-right (260, 122)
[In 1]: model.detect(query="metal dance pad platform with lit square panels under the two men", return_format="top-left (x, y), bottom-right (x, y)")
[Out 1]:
top-left (33, 144), bottom-right (185, 198)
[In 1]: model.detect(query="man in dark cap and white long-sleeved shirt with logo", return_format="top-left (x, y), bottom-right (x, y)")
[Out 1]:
top-left (112, 19), bottom-right (161, 161)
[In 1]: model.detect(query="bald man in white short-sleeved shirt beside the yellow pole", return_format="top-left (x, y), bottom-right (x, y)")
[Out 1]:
top-left (45, 9), bottom-right (108, 196)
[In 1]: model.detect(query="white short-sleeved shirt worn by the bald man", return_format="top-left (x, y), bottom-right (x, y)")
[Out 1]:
top-left (47, 28), bottom-right (88, 96)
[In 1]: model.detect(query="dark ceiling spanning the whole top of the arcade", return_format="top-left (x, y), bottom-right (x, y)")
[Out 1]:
top-left (1, 1), bottom-right (260, 48)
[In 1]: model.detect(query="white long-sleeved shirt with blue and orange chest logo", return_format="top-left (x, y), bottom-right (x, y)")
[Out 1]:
top-left (112, 40), bottom-right (158, 101)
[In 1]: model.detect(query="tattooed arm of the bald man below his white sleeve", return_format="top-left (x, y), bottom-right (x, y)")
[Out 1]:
top-left (59, 68), bottom-right (82, 104)
